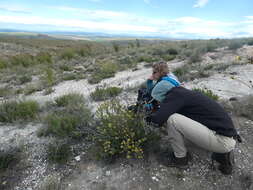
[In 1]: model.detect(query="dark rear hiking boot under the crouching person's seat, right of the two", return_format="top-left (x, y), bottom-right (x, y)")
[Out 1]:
top-left (212, 151), bottom-right (235, 175)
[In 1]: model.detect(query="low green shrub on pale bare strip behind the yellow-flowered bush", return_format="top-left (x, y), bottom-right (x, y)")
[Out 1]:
top-left (90, 87), bottom-right (122, 101)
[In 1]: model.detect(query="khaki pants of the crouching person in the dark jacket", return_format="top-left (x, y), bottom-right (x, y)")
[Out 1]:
top-left (167, 114), bottom-right (236, 158)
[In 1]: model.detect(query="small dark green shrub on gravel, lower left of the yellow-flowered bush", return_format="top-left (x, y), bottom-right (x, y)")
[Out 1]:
top-left (47, 142), bottom-right (72, 164)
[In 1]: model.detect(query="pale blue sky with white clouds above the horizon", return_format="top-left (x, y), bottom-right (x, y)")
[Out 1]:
top-left (0, 0), bottom-right (253, 39)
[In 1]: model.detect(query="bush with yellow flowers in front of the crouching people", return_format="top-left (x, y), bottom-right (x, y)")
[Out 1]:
top-left (93, 101), bottom-right (156, 160)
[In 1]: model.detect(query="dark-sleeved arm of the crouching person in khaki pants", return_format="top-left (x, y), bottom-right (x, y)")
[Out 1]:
top-left (149, 92), bottom-right (184, 126)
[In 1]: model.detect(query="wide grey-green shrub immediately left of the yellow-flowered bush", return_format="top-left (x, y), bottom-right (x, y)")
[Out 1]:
top-left (38, 94), bottom-right (92, 139)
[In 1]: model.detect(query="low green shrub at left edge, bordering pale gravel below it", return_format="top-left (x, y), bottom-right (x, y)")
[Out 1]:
top-left (0, 100), bottom-right (39, 122)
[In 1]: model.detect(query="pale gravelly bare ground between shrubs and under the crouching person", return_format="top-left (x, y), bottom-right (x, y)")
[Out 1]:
top-left (0, 46), bottom-right (253, 190)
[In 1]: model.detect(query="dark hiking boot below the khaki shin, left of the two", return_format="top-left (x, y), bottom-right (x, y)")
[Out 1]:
top-left (167, 152), bottom-right (189, 169)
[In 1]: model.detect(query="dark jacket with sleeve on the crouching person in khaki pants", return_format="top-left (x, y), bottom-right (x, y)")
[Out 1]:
top-left (150, 87), bottom-right (237, 137)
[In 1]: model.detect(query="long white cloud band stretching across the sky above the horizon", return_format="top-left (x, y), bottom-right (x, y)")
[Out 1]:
top-left (0, 7), bottom-right (253, 38)
